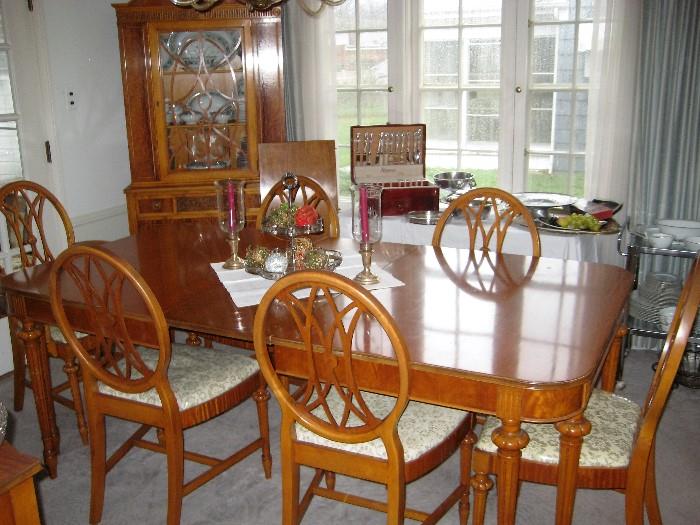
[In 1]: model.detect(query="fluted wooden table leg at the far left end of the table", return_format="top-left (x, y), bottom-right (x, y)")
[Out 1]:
top-left (17, 319), bottom-right (60, 478)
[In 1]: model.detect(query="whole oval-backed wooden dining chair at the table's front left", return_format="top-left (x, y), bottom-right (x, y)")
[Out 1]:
top-left (49, 246), bottom-right (271, 525)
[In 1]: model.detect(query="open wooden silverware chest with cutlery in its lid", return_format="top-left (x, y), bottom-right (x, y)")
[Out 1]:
top-left (350, 124), bottom-right (439, 215)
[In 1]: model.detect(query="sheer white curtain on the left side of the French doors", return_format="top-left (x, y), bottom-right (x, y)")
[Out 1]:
top-left (285, 2), bottom-right (337, 140)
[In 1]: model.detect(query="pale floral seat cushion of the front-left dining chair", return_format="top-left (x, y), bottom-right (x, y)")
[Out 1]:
top-left (99, 344), bottom-right (260, 410)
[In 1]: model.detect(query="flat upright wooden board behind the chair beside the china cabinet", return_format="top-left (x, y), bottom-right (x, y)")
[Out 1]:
top-left (258, 140), bottom-right (338, 210)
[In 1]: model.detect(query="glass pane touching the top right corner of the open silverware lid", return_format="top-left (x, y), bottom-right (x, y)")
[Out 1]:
top-left (423, 91), bottom-right (459, 148)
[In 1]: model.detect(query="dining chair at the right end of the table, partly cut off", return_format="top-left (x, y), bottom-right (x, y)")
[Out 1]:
top-left (471, 256), bottom-right (700, 525)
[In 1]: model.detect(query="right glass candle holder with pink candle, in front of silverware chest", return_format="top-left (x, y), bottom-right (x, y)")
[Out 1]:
top-left (350, 184), bottom-right (382, 284)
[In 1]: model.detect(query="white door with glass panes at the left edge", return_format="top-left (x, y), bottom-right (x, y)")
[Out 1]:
top-left (0, 0), bottom-right (56, 374)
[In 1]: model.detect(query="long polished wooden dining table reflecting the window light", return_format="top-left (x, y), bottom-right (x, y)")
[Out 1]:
top-left (1, 223), bottom-right (633, 523)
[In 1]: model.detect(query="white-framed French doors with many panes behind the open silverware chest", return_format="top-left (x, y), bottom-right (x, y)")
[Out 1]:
top-left (335, 0), bottom-right (593, 195)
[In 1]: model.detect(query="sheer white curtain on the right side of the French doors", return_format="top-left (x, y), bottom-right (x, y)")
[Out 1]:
top-left (585, 0), bottom-right (641, 215)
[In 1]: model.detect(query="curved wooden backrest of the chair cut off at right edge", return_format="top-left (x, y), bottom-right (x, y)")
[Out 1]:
top-left (627, 255), bottom-right (700, 490)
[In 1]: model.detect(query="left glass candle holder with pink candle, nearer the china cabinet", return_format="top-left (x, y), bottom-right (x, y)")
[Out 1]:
top-left (214, 179), bottom-right (245, 270)
